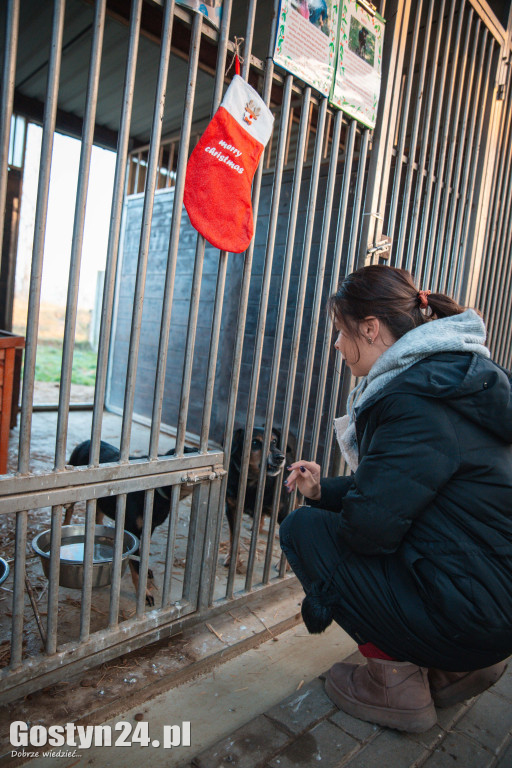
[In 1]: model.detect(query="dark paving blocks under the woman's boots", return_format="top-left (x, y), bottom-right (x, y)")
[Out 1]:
top-left (191, 652), bottom-right (512, 768)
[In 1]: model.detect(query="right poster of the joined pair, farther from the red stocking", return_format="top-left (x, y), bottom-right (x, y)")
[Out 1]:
top-left (330, 0), bottom-right (385, 128)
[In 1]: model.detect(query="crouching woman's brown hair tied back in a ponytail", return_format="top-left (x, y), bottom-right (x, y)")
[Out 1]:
top-left (327, 264), bottom-right (464, 340)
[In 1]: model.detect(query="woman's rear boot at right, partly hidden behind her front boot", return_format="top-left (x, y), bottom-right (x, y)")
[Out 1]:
top-left (428, 661), bottom-right (507, 708)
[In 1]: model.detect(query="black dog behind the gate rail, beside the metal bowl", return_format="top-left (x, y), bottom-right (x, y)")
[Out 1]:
top-left (64, 440), bottom-right (195, 606)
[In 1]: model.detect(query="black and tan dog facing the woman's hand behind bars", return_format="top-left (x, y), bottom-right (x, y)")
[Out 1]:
top-left (224, 427), bottom-right (295, 571)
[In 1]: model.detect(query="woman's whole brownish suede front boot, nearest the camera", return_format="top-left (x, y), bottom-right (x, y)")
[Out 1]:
top-left (325, 659), bottom-right (437, 733)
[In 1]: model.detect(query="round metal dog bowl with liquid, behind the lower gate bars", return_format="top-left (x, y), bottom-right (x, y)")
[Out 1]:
top-left (32, 525), bottom-right (139, 589)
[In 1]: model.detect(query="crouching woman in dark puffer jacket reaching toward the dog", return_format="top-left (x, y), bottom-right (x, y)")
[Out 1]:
top-left (280, 266), bottom-right (512, 732)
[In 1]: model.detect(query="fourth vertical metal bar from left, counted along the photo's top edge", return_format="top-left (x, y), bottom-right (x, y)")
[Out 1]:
top-left (90, 0), bottom-right (142, 466)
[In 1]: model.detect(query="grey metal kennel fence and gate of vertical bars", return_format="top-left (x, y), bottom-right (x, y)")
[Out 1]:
top-left (0, 0), bottom-right (512, 701)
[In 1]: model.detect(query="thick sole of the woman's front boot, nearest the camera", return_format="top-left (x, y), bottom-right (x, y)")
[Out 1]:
top-left (325, 677), bottom-right (437, 733)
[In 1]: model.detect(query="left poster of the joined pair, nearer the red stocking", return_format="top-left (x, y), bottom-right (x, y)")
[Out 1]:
top-left (273, 0), bottom-right (338, 96)
